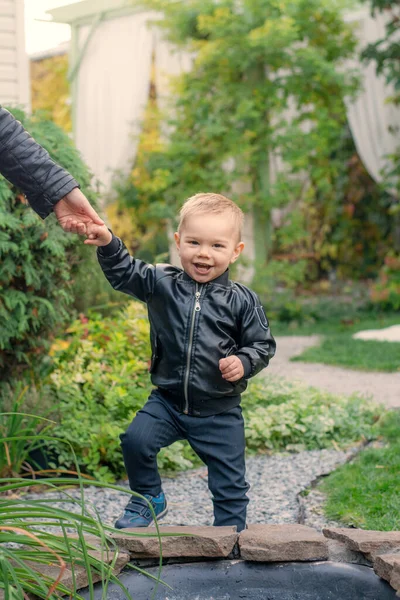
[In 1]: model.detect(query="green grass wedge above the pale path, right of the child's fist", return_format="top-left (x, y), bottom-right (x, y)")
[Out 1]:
top-left (291, 333), bottom-right (400, 372)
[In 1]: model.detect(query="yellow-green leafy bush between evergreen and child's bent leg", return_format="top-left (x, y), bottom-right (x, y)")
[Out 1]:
top-left (50, 302), bottom-right (150, 480)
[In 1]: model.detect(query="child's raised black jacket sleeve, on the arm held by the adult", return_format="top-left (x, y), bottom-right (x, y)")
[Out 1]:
top-left (97, 235), bottom-right (156, 302)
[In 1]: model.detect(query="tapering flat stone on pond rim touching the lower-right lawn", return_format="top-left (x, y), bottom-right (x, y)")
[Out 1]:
top-left (322, 527), bottom-right (400, 561)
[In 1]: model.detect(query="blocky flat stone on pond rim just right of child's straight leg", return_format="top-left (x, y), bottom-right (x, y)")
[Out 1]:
top-left (239, 525), bottom-right (329, 562)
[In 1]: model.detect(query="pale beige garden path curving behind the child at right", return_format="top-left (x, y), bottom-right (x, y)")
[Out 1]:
top-left (266, 335), bottom-right (400, 408)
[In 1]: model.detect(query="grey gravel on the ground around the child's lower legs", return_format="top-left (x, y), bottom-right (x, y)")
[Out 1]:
top-left (24, 447), bottom-right (358, 528)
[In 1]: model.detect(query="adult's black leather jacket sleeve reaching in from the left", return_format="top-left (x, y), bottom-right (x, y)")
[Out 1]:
top-left (0, 106), bottom-right (79, 219)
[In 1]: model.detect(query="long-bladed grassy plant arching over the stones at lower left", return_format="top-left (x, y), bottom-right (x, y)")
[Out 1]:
top-left (0, 424), bottom-right (168, 600)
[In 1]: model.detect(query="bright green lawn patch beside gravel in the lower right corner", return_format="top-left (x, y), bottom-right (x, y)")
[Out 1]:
top-left (320, 411), bottom-right (400, 531)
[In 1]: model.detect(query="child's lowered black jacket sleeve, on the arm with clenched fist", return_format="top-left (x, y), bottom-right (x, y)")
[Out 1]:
top-left (235, 288), bottom-right (276, 379)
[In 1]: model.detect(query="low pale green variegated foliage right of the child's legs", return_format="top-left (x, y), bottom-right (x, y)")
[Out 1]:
top-left (242, 377), bottom-right (384, 452)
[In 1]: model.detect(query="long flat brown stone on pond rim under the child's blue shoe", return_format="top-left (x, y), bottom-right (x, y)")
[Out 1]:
top-left (111, 526), bottom-right (239, 558)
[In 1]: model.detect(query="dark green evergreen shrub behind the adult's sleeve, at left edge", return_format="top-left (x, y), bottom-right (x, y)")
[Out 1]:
top-left (0, 111), bottom-right (95, 381)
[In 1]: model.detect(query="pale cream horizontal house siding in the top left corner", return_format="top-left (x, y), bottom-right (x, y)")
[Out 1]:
top-left (0, 0), bottom-right (30, 109)
